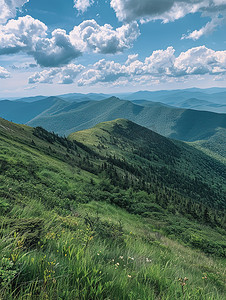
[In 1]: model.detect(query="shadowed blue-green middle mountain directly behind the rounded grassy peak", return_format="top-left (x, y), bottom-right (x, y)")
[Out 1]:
top-left (28, 97), bottom-right (226, 141)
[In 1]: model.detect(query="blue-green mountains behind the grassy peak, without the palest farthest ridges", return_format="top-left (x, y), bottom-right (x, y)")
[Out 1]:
top-left (0, 97), bottom-right (226, 162)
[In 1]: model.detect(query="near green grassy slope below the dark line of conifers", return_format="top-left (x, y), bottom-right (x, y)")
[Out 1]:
top-left (0, 118), bottom-right (226, 300)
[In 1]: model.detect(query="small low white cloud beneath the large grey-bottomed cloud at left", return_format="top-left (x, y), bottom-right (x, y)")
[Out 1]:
top-left (29, 64), bottom-right (85, 84)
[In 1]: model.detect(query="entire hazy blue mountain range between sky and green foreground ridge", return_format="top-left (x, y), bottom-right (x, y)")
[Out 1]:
top-left (0, 89), bottom-right (226, 160)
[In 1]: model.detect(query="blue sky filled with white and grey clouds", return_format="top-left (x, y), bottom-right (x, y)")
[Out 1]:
top-left (0, 0), bottom-right (226, 98)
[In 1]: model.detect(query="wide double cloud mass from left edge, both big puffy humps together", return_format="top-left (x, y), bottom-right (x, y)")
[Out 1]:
top-left (0, 16), bottom-right (140, 67)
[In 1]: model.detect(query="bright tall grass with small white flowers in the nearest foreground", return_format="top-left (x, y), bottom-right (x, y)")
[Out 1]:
top-left (0, 202), bottom-right (225, 300)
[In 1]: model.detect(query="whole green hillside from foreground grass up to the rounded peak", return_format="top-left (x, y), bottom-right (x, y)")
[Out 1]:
top-left (0, 119), bottom-right (226, 300)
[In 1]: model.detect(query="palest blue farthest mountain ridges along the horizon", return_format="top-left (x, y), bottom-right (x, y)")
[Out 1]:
top-left (0, 88), bottom-right (226, 113)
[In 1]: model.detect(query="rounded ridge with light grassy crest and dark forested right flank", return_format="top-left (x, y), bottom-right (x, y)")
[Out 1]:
top-left (69, 119), bottom-right (226, 210)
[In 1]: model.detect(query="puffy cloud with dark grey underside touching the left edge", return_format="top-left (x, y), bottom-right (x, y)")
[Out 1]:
top-left (0, 16), bottom-right (81, 67)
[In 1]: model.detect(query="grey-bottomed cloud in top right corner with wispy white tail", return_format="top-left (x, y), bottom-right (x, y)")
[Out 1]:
top-left (110, 0), bottom-right (226, 40)
